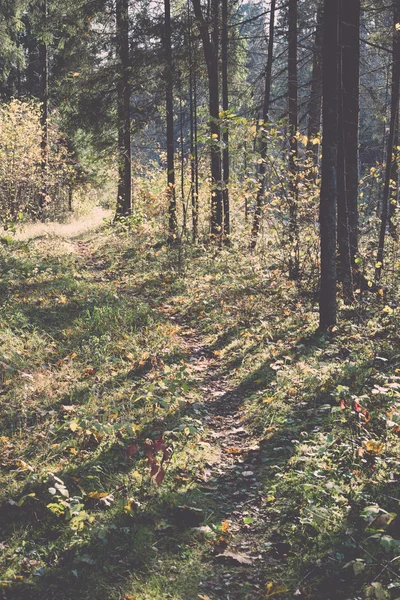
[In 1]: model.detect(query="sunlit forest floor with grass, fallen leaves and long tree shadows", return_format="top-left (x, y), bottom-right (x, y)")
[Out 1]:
top-left (0, 215), bottom-right (400, 600)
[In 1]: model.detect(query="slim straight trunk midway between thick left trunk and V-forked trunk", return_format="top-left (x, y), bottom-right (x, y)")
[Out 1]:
top-left (164, 0), bottom-right (178, 244)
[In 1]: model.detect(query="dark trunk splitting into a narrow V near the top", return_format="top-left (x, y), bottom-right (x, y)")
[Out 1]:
top-left (192, 0), bottom-right (223, 239)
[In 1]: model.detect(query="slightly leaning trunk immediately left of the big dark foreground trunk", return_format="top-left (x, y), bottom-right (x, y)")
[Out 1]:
top-left (307, 2), bottom-right (324, 166)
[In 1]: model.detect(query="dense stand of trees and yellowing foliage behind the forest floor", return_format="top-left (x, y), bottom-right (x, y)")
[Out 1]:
top-left (0, 1), bottom-right (399, 327)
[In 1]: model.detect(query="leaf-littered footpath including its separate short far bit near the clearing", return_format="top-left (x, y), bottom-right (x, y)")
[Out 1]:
top-left (73, 229), bottom-right (270, 600)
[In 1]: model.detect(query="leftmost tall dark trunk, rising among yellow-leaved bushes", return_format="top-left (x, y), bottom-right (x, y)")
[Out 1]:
top-left (39, 0), bottom-right (49, 213)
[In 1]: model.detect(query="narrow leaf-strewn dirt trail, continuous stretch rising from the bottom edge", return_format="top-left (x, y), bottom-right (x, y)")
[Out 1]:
top-left (178, 324), bottom-right (270, 600)
